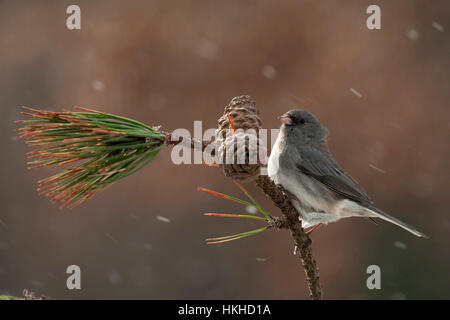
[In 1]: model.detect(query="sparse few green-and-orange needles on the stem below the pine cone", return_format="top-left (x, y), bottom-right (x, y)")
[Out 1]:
top-left (198, 180), bottom-right (273, 244)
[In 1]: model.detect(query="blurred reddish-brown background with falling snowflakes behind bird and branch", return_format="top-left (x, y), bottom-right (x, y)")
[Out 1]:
top-left (0, 0), bottom-right (450, 299)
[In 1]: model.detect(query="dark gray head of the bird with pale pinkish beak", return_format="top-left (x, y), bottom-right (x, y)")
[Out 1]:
top-left (279, 109), bottom-right (328, 142)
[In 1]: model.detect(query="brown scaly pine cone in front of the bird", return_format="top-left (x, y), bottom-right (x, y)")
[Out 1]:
top-left (216, 96), bottom-right (263, 180)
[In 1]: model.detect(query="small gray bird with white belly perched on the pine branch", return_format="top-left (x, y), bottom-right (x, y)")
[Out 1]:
top-left (267, 109), bottom-right (428, 238)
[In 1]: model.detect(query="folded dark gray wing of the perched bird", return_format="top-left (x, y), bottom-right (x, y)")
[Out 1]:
top-left (294, 145), bottom-right (373, 205)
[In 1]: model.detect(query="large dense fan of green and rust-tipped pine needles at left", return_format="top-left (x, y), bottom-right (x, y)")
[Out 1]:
top-left (16, 107), bottom-right (165, 208)
